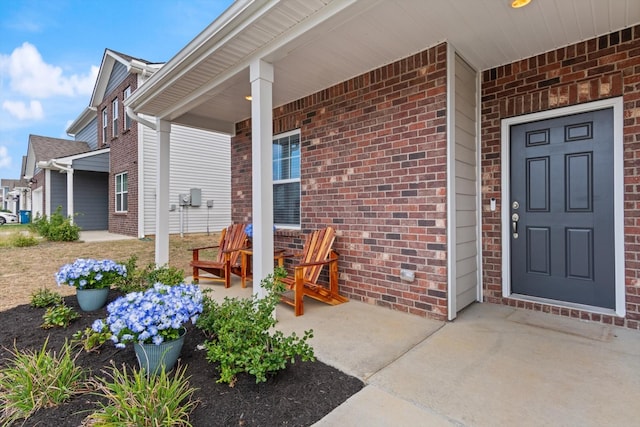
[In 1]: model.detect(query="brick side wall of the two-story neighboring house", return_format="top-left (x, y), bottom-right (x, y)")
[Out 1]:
top-left (98, 74), bottom-right (138, 236)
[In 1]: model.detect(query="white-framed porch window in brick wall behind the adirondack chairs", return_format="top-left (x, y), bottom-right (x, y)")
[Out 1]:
top-left (273, 130), bottom-right (300, 227)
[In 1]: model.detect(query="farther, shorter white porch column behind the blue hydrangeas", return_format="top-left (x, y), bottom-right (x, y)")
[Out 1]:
top-left (156, 119), bottom-right (171, 266)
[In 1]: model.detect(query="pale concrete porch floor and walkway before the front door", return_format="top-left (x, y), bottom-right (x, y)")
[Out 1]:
top-left (201, 280), bottom-right (640, 427)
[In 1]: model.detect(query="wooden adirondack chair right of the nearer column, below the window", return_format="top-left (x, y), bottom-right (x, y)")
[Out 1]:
top-left (282, 227), bottom-right (349, 316)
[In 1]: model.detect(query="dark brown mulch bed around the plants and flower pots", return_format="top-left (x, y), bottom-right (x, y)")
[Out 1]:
top-left (0, 294), bottom-right (363, 427)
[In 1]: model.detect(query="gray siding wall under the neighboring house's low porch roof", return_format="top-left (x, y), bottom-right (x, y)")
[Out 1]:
top-left (73, 171), bottom-right (109, 230)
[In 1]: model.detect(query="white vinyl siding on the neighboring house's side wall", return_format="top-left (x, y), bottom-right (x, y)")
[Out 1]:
top-left (142, 125), bottom-right (231, 235)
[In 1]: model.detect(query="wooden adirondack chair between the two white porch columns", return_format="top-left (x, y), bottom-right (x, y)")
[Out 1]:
top-left (189, 224), bottom-right (247, 288)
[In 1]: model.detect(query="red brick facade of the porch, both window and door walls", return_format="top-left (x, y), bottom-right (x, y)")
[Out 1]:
top-left (232, 27), bottom-right (640, 329)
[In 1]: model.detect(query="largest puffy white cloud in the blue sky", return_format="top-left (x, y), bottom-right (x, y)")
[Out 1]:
top-left (0, 42), bottom-right (98, 98)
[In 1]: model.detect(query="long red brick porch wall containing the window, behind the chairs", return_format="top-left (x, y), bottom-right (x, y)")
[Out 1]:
top-left (232, 44), bottom-right (447, 319)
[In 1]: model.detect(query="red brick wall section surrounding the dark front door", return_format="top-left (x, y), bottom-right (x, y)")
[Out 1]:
top-left (482, 26), bottom-right (640, 329)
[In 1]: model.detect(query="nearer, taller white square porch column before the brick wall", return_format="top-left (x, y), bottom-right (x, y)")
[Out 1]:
top-left (250, 60), bottom-right (273, 298)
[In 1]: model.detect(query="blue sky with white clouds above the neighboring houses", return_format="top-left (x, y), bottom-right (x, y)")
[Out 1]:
top-left (0, 0), bottom-right (233, 179)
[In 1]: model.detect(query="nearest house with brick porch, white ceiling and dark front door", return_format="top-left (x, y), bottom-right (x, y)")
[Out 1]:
top-left (122, 0), bottom-right (640, 329)
